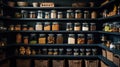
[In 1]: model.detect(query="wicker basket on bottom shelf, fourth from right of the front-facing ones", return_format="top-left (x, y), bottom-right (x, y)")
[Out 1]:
top-left (34, 60), bottom-right (49, 67)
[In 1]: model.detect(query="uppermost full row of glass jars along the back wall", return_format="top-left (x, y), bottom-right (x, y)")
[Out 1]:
top-left (15, 9), bottom-right (97, 19)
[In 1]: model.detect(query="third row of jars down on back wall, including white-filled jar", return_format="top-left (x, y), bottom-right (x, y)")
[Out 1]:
top-left (16, 33), bottom-right (94, 44)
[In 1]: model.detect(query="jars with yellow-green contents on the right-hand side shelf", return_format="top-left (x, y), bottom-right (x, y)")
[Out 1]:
top-left (103, 22), bottom-right (120, 32)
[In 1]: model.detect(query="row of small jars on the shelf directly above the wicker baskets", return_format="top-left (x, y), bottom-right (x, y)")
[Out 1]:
top-left (15, 47), bottom-right (97, 56)
